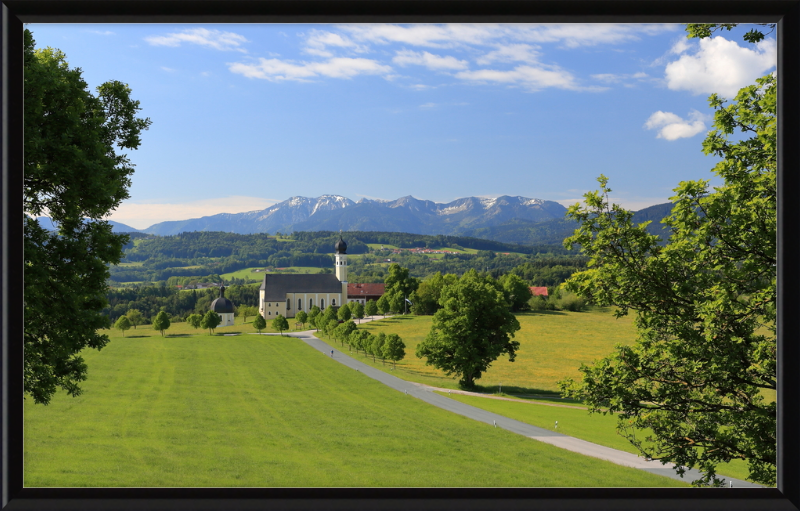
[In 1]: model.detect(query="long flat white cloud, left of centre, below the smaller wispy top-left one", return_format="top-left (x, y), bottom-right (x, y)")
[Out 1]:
top-left (228, 57), bottom-right (392, 82)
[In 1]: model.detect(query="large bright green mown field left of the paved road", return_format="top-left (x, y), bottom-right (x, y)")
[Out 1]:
top-left (24, 324), bottom-right (684, 487)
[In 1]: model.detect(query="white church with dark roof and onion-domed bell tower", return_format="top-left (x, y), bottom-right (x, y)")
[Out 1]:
top-left (258, 237), bottom-right (348, 320)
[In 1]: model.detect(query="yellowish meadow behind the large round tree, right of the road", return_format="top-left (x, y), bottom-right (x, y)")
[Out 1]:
top-left (360, 309), bottom-right (636, 394)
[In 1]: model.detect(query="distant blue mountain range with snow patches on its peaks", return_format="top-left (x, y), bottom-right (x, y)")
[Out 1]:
top-left (34, 195), bottom-right (672, 244)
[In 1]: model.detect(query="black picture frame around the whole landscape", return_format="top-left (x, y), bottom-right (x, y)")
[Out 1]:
top-left (0, 0), bottom-right (800, 511)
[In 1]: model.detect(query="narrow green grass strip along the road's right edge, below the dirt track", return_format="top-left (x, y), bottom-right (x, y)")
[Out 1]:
top-left (444, 393), bottom-right (748, 486)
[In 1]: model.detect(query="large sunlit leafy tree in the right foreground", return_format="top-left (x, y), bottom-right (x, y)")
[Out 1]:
top-left (562, 25), bottom-right (777, 485)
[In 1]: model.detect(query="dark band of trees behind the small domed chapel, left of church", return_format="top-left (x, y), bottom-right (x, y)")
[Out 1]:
top-left (102, 282), bottom-right (259, 324)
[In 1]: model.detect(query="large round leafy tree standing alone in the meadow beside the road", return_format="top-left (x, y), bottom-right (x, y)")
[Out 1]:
top-left (416, 270), bottom-right (520, 388)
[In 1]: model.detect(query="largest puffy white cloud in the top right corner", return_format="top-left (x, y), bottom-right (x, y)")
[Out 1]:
top-left (665, 36), bottom-right (778, 98)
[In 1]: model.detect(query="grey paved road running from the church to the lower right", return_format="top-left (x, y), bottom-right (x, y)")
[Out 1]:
top-left (253, 320), bottom-right (763, 488)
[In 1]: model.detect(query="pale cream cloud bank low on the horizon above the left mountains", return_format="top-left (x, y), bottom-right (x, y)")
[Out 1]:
top-left (109, 195), bottom-right (280, 229)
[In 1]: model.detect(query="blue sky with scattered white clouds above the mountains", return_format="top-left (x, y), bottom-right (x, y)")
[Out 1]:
top-left (27, 24), bottom-right (777, 229)
